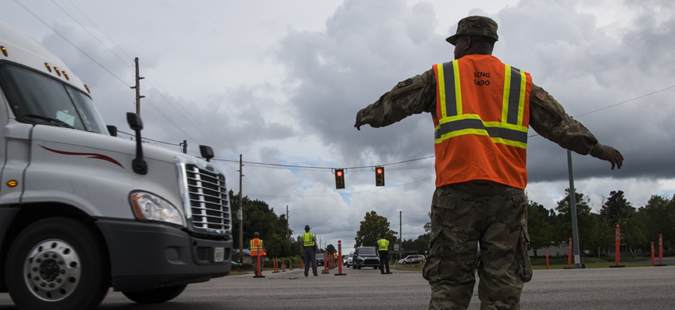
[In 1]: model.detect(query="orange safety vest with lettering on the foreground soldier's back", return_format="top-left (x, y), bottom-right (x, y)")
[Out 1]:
top-left (432, 55), bottom-right (532, 189)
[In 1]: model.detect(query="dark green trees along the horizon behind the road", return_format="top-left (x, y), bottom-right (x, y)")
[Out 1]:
top-left (229, 189), bottom-right (675, 260)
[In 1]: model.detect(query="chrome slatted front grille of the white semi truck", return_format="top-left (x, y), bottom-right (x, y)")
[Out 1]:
top-left (185, 164), bottom-right (230, 234)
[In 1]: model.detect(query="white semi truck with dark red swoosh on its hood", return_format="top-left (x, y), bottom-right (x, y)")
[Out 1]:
top-left (0, 21), bottom-right (233, 310)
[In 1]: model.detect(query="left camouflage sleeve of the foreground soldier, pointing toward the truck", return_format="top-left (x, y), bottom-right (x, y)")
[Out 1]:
top-left (355, 69), bottom-right (436, 128)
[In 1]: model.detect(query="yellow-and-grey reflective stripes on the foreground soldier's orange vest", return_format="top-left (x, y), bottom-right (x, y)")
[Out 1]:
top-left (434, 60), bottom-right (531, 148)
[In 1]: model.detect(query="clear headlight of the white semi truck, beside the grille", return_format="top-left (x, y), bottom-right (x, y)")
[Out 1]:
top-left (129, 192), bottom-right (185, 226)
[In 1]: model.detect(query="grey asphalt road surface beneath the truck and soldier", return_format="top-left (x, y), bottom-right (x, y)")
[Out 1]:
top-left (0, 266), bottom-right (675, 310)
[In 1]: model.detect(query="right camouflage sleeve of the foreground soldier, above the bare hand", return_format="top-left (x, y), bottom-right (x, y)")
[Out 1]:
top-left (530, 85), bottom-right (603, 157)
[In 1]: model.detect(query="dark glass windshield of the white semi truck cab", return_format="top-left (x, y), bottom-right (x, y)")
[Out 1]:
top-left (0, 64), bottom-right (108, 135)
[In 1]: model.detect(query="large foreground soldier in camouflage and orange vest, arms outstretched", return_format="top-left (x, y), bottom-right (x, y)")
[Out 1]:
top-left (354, 16), bottom-right (623, 309)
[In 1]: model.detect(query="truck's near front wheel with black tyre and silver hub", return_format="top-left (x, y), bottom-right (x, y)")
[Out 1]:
top-left (5, 217), bottom-right (110, 310)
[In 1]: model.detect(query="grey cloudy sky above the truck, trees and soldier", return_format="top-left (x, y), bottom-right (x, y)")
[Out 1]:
top-left (0, 0), bottom-right (675, 251)
